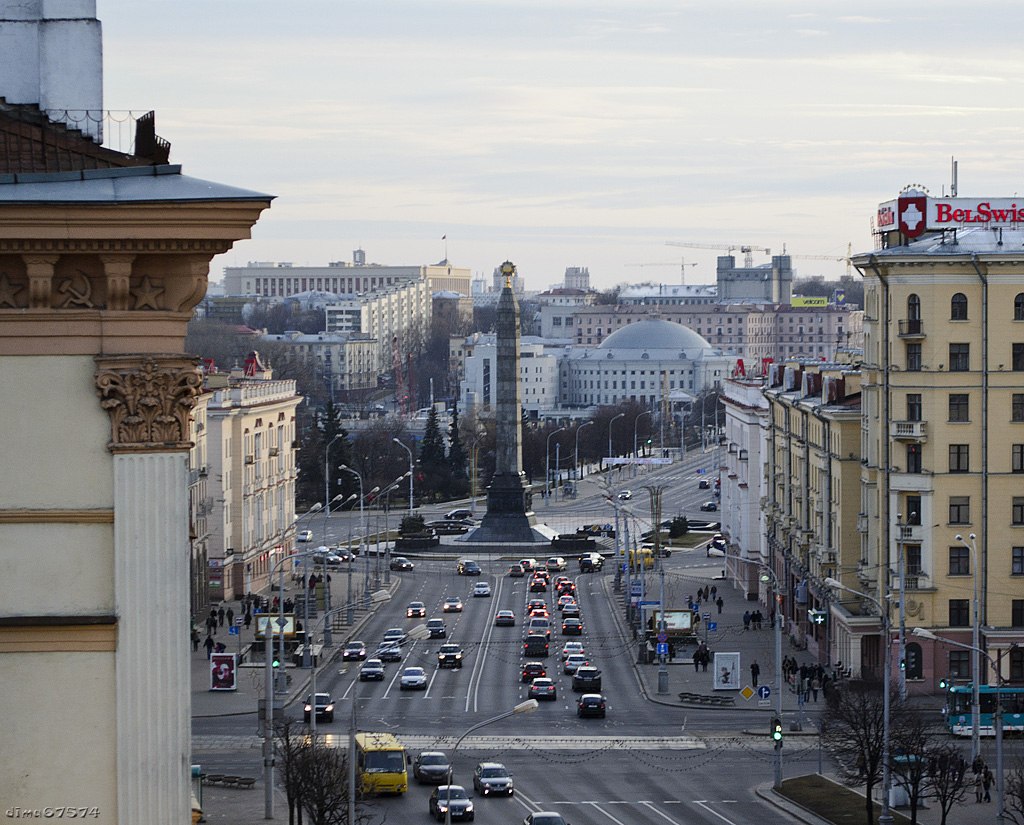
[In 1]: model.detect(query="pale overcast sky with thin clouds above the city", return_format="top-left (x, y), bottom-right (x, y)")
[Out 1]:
top-left (97, 0), bottom-right (1024, 289)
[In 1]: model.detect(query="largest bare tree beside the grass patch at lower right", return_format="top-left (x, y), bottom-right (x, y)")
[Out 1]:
top-left (821, 680), bottom-right (898, 825)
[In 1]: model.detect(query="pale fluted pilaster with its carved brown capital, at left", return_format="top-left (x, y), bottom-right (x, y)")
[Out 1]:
top-left (95, 355), bottom-right (201, 825)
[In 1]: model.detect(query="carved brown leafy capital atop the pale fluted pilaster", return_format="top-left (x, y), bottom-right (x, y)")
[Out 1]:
top-left (95, 355), bottom-right (203, 453)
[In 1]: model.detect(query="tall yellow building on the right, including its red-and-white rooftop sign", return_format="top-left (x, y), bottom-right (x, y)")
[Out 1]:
top-left (847, 191), bottom-right (1024, 694)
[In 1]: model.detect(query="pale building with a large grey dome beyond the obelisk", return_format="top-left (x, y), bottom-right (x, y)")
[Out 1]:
top-left (560, 318), bottom-right (736, 406)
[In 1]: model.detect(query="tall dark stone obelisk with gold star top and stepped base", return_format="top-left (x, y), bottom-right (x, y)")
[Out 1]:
top-left (463, 261), bottom-right (554, 545)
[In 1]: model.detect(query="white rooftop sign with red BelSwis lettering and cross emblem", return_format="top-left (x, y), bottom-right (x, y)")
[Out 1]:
top-left (877, 194), bottom-right (1024, 237)
